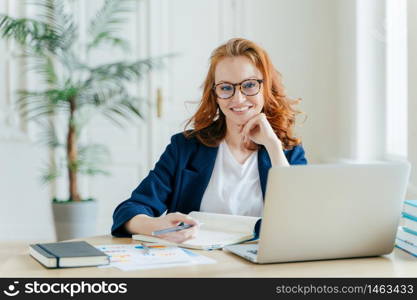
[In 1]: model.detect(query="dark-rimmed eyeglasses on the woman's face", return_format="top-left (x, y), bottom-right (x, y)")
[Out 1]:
top-left (213, 79), bottom-right (263, 99)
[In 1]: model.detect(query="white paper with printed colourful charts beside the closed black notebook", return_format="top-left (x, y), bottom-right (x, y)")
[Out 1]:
top-left (95, 243), bottom-right (215, 271)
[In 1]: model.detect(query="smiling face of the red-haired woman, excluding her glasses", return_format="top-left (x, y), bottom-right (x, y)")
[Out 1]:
top-left (214, 56), bottom-right (264, 128)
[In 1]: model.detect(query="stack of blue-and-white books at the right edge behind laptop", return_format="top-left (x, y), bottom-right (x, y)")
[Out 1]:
top-left (395, 200), bottom-right (417, 256)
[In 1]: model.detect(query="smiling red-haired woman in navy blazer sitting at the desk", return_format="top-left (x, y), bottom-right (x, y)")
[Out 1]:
top-left (112, 39), bottom-right (307, 242)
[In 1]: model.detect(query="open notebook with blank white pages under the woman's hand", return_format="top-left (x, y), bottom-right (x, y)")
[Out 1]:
top-left (132, 211), bottom-right (260, 250)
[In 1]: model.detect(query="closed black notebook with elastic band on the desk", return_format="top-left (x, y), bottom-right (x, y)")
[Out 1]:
top-left (29, 242), bottom-right (110, 268)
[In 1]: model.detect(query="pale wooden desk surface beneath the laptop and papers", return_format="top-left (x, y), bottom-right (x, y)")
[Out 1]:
top-left (0, 236), bottom-right (417, 278)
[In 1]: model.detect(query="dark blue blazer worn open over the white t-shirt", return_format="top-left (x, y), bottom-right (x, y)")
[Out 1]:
top-left (111, 133), bottom-right (307, 237)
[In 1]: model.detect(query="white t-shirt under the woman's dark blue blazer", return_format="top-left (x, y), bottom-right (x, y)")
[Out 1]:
top-left (200, 140), bottom-right (263, 217)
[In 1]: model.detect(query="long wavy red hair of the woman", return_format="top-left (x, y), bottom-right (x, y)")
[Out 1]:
top-left (184, 38), bottom-right (301, 150)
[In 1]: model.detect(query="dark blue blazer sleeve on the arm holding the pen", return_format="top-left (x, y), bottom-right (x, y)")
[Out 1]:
top-left (111, 136), bottom-right (178, 237)
